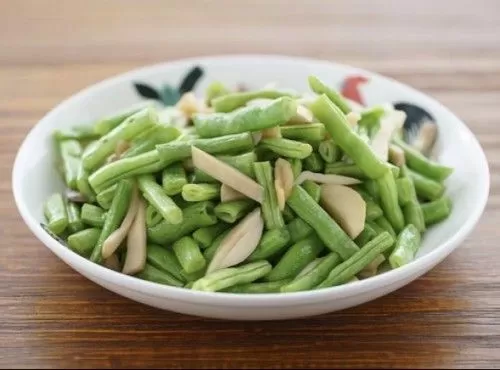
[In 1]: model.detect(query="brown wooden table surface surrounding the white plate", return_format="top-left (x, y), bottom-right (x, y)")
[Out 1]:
top-left (0, 0), bottom-right (500, 368)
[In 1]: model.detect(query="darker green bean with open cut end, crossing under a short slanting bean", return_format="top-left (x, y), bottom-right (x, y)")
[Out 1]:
top-left (148, 201), bottom-right (218, 244)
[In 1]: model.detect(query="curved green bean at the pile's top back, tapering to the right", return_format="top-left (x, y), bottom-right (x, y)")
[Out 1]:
top-left (211, 89), bottom-right (295, 113)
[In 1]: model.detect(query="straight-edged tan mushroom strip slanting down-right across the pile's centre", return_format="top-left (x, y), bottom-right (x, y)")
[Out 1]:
top-left (191, 146), bottom-right (264, 203)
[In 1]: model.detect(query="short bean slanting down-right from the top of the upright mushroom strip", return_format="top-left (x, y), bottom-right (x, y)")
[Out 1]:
top-left (137, 175), bottom-right (182, 225)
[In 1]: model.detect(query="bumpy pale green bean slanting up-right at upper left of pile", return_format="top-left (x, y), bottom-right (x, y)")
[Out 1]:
top-left (82, 108), bottom-right (158, 171)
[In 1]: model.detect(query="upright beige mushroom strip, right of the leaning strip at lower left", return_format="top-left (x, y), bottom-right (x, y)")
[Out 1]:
top-left (122, 199), bottom-right (147, 275)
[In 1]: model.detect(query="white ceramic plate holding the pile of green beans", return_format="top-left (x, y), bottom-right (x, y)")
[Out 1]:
top-left (12, 55), bottom-right (489, 320)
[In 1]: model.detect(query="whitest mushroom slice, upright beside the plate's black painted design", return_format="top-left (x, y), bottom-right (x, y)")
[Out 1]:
top-left (370, 110), bottom-right (406, 162)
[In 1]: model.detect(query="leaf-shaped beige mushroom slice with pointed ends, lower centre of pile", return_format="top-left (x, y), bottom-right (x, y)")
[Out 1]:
top-left (206, 208), bottom-right (264, 274)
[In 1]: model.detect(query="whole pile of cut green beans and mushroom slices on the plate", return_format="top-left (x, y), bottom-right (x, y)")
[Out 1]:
top-left (44, 76), bottom-right (452, 293)
